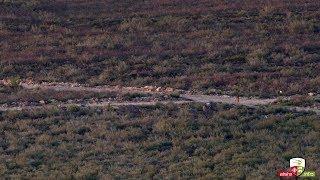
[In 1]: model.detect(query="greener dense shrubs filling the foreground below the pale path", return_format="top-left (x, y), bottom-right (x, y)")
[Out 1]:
top-left (0, 104), bottom-right (320, 179)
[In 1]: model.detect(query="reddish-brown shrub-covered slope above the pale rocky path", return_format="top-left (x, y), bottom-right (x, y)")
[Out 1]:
top-left (0, 0), bottom-right (320, 96)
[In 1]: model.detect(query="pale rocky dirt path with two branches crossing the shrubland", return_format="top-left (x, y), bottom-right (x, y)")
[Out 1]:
top-left (0, 82), bottom-right (320, 114)
